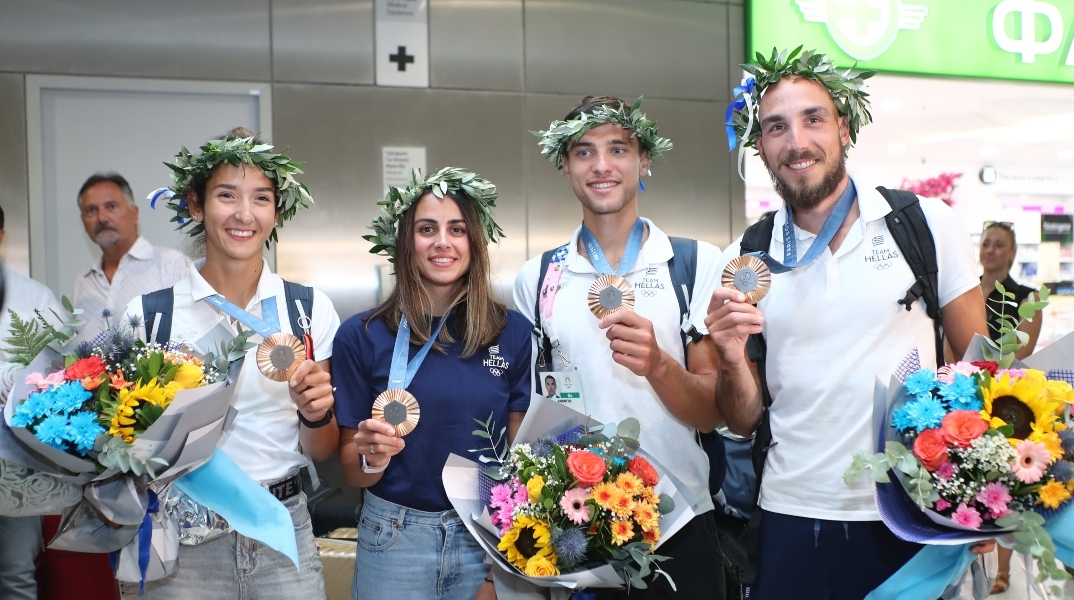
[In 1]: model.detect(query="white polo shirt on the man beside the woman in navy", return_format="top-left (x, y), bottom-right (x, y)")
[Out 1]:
top-left (514, 219), bottom-right (720, 513)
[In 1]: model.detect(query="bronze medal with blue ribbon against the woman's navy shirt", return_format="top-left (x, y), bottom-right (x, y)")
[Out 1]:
top-left (373, 308), bottom-right (451, 437)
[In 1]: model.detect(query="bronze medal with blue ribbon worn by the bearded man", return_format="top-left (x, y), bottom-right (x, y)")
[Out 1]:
top-left (720, 181), bottom-right (857, 304)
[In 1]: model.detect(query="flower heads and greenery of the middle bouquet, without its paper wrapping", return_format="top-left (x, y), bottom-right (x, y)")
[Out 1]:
top-left (478, 420), bottom-right (673, 588)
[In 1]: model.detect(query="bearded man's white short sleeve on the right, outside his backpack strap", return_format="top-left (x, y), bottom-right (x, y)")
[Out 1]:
top-left (921, 197), bottom-right (981, 307)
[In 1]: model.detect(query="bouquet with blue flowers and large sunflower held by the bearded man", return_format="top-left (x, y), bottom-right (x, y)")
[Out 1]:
top-left (844, 290), bottom-right (1074, 598)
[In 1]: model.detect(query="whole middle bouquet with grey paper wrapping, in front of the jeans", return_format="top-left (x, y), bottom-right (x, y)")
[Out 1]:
top-left (444, 399), bottom-right (694, 588)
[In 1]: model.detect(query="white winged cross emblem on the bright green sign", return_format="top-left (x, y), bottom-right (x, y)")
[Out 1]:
top-left (795, 0), bottom-right (929, 60)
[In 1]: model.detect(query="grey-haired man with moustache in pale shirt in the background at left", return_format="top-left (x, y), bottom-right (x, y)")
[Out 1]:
top-left (73, 173), bottom-right (189, 336)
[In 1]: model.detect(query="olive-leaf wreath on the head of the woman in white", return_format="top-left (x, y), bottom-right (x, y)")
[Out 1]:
top-left (154, 136), bottom-right (314, 246)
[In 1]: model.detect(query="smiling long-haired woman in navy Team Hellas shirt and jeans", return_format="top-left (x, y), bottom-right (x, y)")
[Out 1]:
top-left (333, 167), bottom-right (532, 600)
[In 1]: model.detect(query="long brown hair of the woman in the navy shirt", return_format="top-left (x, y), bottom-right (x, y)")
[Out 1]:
top-left (366, 192), bottom-right (507, 358)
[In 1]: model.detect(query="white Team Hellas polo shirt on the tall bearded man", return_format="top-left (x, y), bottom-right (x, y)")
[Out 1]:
top-left (720, 179), bottom-right (981, 521)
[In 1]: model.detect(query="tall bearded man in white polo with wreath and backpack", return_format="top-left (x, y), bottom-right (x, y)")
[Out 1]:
top-left (705, 48), bottom-right (995, 600)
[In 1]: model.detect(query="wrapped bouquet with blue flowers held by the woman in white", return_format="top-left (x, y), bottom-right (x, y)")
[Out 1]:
top-left (0, 306), bottom-right (252, 588)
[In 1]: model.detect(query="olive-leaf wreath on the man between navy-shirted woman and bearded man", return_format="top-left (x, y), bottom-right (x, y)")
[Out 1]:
top-left (529, 96), bottom-right (673, 171)
